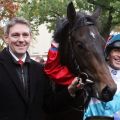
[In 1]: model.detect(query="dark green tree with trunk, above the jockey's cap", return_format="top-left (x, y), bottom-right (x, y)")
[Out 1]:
top-left (87, 0), bottom-right (120, 38)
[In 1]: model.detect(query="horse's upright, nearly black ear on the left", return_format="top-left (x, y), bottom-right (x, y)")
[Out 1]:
top-left (67, 2), bottom-right (76, 24)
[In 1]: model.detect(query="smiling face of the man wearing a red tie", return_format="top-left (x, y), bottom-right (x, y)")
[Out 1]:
top-left (6, 24), bottom-right (32, 58)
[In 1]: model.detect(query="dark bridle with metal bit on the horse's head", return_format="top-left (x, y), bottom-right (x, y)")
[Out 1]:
top-left (68, 17), bottom-right (94, 111)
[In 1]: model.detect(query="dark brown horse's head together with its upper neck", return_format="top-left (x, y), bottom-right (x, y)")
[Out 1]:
top-left (55, 2), bottom-right (116, 101)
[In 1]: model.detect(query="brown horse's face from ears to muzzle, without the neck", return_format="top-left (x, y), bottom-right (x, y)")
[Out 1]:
top-left (67, 3), bottom-right (116, 101)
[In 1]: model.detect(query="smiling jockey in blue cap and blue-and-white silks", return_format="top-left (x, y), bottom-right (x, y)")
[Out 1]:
top-left (84, 34), bottom-right (120, 120)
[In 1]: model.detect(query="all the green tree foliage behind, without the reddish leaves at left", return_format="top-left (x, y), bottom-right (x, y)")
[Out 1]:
top-left (18, 0), bottom-right (120, 38)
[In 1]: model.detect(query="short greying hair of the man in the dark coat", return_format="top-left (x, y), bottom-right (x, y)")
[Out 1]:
top-left (4, 17), bottom-right (31, 35)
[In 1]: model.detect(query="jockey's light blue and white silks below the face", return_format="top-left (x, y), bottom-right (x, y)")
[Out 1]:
top-left (84, 67), bottom-right (120, 120)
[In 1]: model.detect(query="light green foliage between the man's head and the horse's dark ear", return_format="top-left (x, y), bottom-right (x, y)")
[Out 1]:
top-left (18, 0), bottom-right (68, 31)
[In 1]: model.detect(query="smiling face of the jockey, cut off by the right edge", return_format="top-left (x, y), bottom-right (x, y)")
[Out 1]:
top-left (108, 48), bottom-right (120, 69)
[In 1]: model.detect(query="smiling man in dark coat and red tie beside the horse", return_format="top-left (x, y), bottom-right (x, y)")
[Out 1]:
top-left (0, 18), bottom-right (81, 120)
